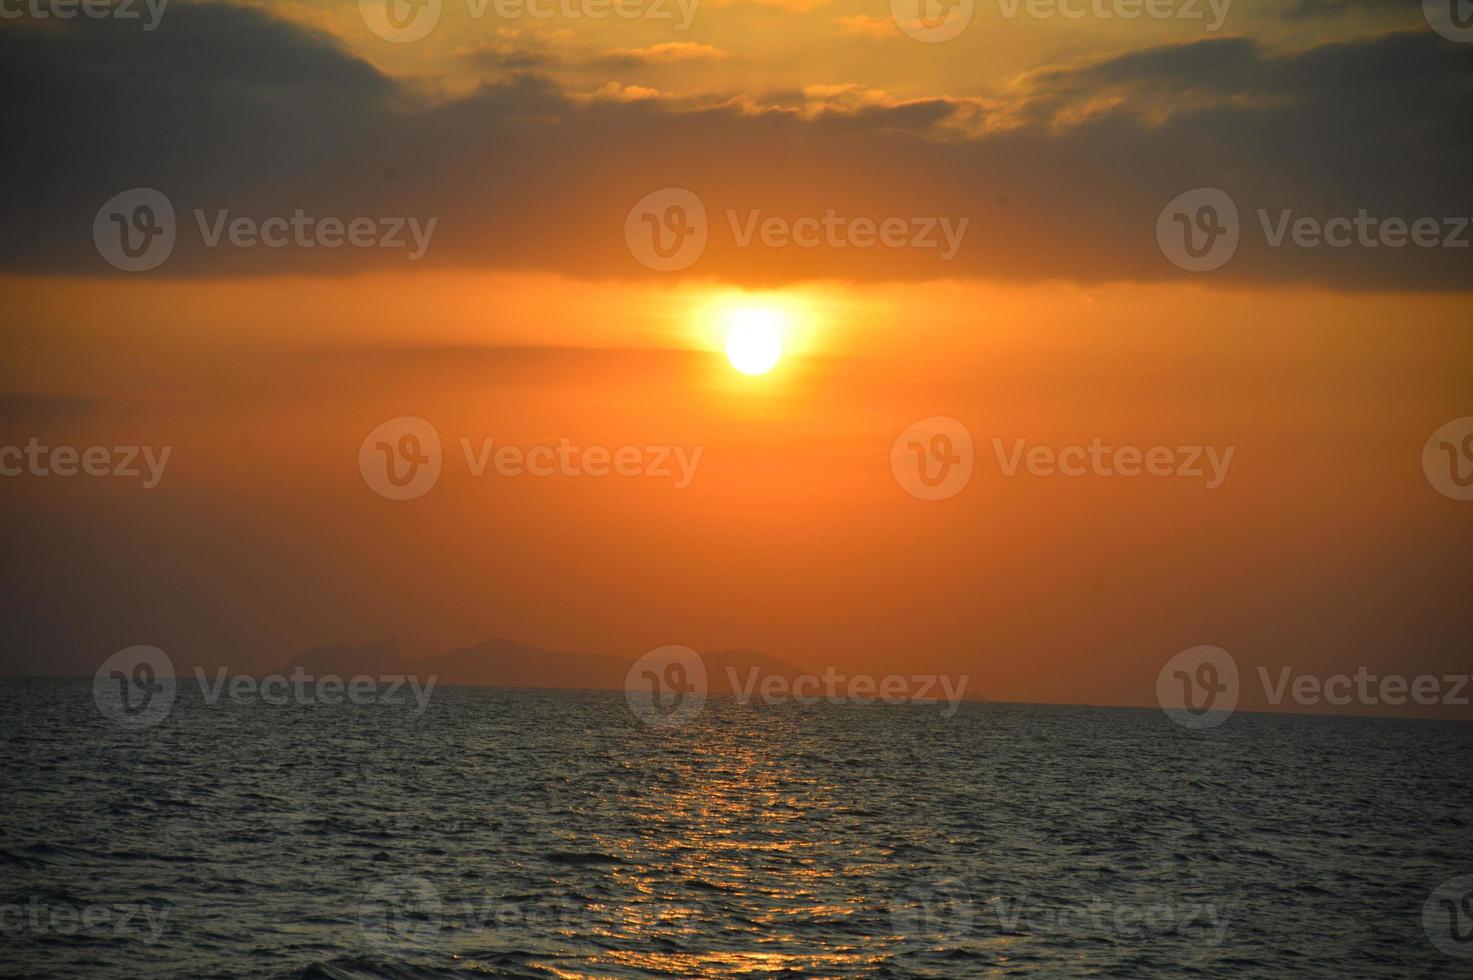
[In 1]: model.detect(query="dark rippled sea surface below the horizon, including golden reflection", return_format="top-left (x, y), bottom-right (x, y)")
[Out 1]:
top-left (0, 679), bottom-right (1473, 980)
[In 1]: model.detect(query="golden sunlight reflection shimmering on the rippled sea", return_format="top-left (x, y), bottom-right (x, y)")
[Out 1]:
top-left (471, 719), bottom-right (930, 980)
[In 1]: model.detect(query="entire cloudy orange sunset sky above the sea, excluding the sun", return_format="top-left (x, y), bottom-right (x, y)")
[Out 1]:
top-left (0, 0), bottom-right (1473, 716)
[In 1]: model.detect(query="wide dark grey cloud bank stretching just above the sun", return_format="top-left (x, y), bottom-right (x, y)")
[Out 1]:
top-left (0, 3), bottom-right (1473, 290)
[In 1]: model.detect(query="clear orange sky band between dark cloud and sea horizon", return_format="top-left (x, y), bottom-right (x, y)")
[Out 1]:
top-left (6, 276), bottom-right (1470, 716)
